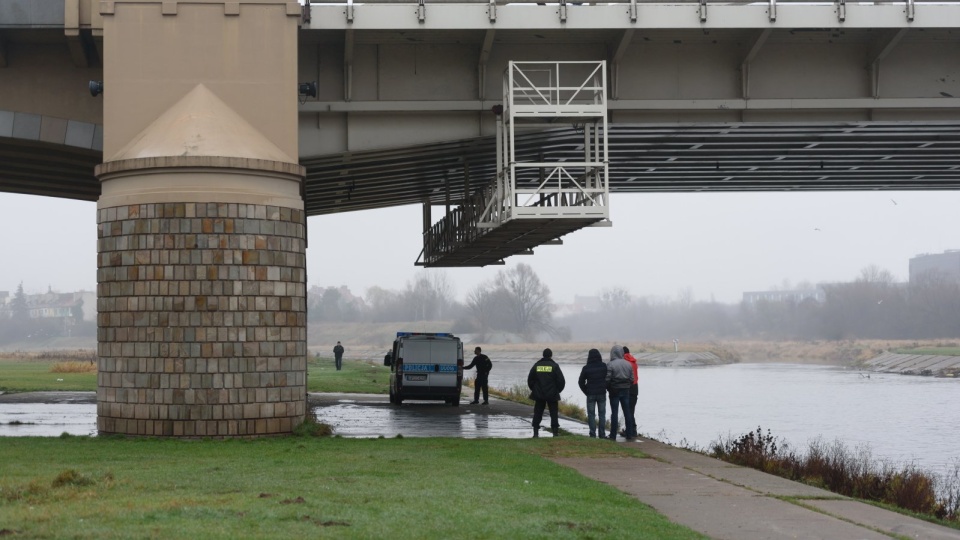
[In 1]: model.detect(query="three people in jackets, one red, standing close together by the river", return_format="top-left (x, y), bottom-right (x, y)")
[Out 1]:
top-left (578, 345), bottom-right (640, 441)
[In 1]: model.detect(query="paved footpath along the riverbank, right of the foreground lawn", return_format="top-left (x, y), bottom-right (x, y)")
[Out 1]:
top-left (555, 439), bottom-right (960, 540)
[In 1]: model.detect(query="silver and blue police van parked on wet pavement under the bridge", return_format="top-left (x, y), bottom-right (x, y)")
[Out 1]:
top-left (384, 332), bottom-right (463, 407)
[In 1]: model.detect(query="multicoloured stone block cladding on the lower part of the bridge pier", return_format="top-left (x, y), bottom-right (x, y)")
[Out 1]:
top-left (97, 203), bottom-right (307, 437)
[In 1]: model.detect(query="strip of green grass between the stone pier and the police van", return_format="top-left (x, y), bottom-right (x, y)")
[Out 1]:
top-left (307, 357), bottom-right (390, 394)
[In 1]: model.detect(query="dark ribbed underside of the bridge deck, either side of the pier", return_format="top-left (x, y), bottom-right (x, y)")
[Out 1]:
top-left (0, 122), bottom-right (960, 211)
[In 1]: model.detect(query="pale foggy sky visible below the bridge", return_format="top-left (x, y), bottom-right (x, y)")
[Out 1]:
top-left (0, 191), bottom-right (960, 303)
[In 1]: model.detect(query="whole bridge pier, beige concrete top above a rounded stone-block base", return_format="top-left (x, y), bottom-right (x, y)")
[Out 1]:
top-left (96, 0), bottom-right (306, 437)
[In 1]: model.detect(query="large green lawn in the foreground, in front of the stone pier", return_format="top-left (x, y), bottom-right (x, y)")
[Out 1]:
top-left (0, 437), bottom-right (702, 540)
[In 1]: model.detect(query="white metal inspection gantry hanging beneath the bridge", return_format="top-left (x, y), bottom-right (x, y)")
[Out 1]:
top-left (416, 61), bottom-right (610, 267)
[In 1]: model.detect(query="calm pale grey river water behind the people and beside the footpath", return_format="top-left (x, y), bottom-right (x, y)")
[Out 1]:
top-left (490, 360), bottom-right (960, 472)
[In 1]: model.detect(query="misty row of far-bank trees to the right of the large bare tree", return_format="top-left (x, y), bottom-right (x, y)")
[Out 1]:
top-left (560, 266), bottom-right (960, 341)
